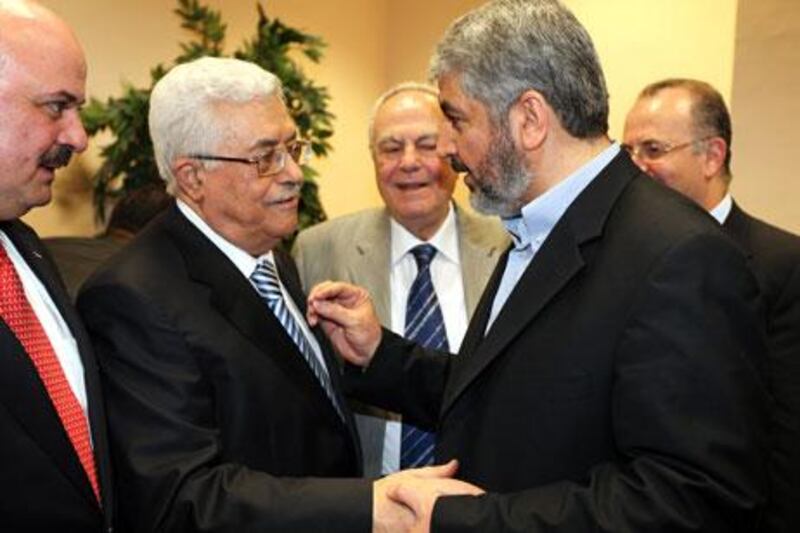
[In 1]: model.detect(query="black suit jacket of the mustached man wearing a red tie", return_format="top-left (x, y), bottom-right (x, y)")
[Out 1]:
top-left (0, 221), bottom-right (114, 532)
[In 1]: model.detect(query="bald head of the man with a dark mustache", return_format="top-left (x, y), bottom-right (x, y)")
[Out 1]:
top-left (0, 0), bottom-right (86, 220)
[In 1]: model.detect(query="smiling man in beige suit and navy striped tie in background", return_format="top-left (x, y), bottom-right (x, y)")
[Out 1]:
top-left (293, 82), bottom-right (509, 475)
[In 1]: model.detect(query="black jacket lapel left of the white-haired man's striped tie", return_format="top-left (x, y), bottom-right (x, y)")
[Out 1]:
top-left (165, 208), bottom-right (348, 428)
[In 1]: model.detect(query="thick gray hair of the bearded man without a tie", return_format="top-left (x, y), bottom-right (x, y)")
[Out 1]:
top-left (430, 0), bottom-right (608, 139)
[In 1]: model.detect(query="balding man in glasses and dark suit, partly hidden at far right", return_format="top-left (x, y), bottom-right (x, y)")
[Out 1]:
top-left (624, 79), bottom-right (800, 533)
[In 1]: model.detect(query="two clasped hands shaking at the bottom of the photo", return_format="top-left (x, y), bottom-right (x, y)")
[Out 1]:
top-left (372, 460), bottom-right (484, 533)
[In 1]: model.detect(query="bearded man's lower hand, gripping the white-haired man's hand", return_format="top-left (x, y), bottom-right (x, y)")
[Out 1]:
top-left (387, 461), bottom-right (485, 533)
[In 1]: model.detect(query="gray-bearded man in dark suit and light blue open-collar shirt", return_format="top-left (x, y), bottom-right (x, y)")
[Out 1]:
top-left (309, 0), bottom-right (766, 533)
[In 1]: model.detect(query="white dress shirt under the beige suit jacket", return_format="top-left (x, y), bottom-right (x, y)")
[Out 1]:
top-left (382, 205), bottom-right (468, 474)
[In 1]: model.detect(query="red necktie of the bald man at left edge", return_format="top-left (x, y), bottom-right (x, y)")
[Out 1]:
top-left (0, 243), bottom-right (100, 502)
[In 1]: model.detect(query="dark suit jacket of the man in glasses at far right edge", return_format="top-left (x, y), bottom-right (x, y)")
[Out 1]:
top-left (723, 204), bottom-right (800, 533)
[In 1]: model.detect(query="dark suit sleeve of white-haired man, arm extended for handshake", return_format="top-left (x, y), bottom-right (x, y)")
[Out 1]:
top-left (78, 284), bottom-right (372, 533)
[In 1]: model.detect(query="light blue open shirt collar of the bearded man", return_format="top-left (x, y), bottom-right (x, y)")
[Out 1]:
top-left (503, 143), bottom-right (620, 250)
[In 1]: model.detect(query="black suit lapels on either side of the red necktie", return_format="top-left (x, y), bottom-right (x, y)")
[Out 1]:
top-left (0, 221), bottom-right (101, 505)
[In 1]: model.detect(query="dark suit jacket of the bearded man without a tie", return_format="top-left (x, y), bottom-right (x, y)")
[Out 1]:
top-left (348, 153), bottom-right (766, 533)
